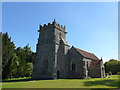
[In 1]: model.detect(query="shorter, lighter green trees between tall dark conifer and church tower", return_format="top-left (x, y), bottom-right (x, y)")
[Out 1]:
top-left (15, 44), bottom-right (33, 77)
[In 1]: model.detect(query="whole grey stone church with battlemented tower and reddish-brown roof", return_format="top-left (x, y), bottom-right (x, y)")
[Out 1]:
top-left (32, 20), bottom-right (105, 79)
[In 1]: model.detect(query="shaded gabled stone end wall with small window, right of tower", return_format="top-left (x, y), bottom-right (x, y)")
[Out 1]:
top-left (67, 48), bottom-right (84, 78)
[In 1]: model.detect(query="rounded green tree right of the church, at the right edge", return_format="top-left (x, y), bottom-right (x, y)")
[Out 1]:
top-left (104, 59), bottom-right (120, 74)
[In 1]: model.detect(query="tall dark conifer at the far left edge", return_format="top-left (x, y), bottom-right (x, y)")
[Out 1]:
top-left (2, 33), bottom-right (15, 78)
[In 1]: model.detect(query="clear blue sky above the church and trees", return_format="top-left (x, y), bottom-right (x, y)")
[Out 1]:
top-left (2, 2), bottom-right (118, 61)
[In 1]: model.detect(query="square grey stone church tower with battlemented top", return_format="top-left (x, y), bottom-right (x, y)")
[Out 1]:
top-left (32, 20), bottom-right (70, 79)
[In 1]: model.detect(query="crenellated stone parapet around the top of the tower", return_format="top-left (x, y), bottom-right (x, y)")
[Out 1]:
top-left (38, 19), bottom-right (66, 32)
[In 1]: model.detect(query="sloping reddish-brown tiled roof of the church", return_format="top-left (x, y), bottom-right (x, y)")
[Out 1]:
top-left (75, 48), bottom-right (99, 60)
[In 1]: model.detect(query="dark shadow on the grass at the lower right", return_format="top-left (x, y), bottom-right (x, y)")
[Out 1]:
top-left (84, 79), bottom-right (119, 88)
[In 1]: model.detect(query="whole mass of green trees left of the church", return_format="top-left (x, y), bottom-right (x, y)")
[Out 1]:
top-left (2, 33), bottom-right (34, 79)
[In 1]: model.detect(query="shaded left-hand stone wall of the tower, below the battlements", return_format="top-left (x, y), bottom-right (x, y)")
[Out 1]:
top-left (32, 25), bottom-right (55, 79)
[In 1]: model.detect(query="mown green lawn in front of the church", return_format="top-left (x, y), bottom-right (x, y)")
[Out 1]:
top-left (2, 75), bottom-right (118, 88)
